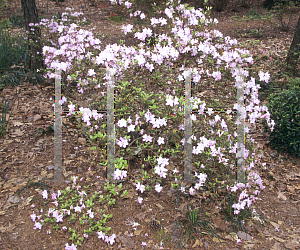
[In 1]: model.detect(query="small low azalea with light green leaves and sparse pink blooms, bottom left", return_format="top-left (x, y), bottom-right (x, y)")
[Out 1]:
top-left (26, 176), bottom-right (125, 249)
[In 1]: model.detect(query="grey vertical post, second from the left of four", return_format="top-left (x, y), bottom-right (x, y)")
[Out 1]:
top-left (106, 69), bottom-right (115, 182)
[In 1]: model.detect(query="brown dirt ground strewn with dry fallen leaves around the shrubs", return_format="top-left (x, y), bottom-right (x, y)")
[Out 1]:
top-left (0, 0), bottom-right (300, 250)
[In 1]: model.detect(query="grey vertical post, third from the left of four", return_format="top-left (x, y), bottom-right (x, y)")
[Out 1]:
top-left (184, 70), bottom-right (192, 184)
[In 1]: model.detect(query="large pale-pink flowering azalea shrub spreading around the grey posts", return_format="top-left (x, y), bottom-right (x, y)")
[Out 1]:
top-left (27, 0), bottom-right (274, 249)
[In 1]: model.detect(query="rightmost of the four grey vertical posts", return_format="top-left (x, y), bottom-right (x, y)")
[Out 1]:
top-left (236, 69), bottom-right (246, 182)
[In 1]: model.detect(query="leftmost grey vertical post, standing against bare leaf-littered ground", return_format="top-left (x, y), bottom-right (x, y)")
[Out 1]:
top-left (54, 69), bottom-right (63, 183)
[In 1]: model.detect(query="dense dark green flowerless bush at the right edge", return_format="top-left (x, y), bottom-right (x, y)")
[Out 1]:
top-left (264, 86), bottom-right (300, 157)
